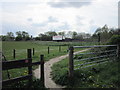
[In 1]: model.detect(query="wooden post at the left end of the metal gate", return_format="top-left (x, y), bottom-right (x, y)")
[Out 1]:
top-left (69, 47), bottom-right (74, 79)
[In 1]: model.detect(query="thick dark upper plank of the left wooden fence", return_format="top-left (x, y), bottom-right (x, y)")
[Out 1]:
top-left (2, 59), bottom-right (30, 70)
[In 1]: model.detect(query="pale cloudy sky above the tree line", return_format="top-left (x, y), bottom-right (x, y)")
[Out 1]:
top-left (0, 0), bottom-right (119, 36)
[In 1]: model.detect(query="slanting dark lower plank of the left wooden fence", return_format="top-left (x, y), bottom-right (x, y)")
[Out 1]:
top-left (2, 75), bottom-right (32, 86)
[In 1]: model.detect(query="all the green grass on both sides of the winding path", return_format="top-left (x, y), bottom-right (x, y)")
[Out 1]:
top-left (2, 41), bottom-right (120, 88)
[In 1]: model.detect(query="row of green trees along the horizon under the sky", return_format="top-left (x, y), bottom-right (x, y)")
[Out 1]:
top-left (0, 25), bottom-right (120, 42)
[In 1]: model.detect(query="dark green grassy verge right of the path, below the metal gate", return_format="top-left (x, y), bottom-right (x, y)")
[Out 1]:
top-left (52, 48), bottom-right (120, 88)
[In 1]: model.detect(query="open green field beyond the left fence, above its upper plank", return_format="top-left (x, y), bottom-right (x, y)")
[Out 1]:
top-left (2, 41), bottom-right (97, 61)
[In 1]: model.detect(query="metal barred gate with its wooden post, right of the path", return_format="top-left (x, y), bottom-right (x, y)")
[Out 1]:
top-left (69, 45), bottom-right (120, 79)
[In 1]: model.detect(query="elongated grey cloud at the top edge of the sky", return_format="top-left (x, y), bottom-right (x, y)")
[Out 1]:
top-left (48, 2), bottom-right (91, 8)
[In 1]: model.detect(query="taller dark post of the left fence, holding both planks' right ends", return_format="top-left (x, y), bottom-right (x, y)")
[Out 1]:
top-left (27, 49), bottom-right (32, 87)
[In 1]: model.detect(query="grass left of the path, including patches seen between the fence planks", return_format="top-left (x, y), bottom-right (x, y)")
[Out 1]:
top-left (2, 41), bottom-right (97, 79)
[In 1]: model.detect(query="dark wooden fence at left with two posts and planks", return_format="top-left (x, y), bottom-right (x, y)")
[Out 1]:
top-left (0, 49), bottom-right (44, 87)
